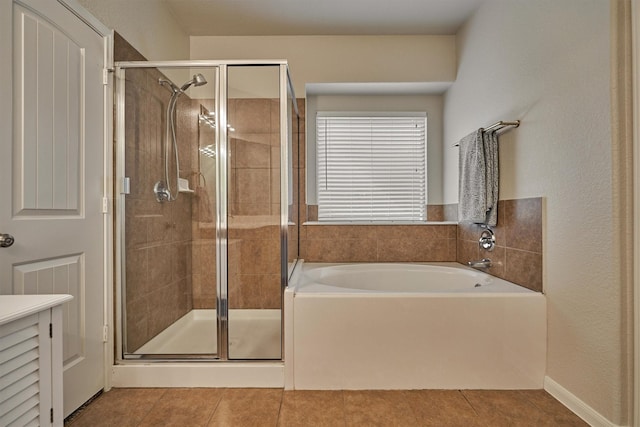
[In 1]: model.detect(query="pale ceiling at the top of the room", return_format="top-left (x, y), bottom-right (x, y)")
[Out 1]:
top-left (164, 0), bottom-right (484, 36)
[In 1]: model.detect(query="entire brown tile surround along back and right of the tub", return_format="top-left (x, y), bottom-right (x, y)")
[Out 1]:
top-left (300, 199), bottom-right (543, 292)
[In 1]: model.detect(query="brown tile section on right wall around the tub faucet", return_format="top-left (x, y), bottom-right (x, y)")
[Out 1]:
top-left (457, 198), bottom-right (543, 292)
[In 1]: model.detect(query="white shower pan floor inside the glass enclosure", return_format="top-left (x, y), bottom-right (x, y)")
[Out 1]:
top-left (134, 309), bottom-right (282, 359)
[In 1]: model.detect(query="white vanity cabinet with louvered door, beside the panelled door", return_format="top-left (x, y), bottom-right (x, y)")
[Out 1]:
top-left (0, 295), bottom-right (72, 426)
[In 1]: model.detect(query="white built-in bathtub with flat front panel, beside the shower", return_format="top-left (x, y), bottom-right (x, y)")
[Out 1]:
top-left (285, 263), bottom-right (546, 389)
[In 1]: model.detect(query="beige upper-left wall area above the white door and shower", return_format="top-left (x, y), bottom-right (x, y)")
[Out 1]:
top-left (78, 0), bottom-right (189, 61)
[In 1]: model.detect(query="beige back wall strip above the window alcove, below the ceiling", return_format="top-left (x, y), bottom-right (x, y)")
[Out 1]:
top-left (191, 36), bottom-right (456, 98)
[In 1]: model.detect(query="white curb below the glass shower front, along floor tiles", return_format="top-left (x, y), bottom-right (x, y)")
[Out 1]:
top-left (112, 362), bottom-right (284, 388)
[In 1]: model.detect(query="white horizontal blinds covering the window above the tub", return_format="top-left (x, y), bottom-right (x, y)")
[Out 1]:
top-left (315, 111), bottom-right (428, 223)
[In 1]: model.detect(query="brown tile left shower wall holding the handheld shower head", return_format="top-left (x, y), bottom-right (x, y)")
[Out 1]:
top-left (114, 35), bottom-right (196, 352)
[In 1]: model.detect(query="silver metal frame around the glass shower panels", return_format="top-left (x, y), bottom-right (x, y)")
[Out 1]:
top-left (114, 60), bottom-right (298, 363)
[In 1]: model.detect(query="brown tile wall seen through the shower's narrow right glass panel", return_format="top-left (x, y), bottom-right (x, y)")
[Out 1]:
top-left (228, 98), bottom-right (281, 309)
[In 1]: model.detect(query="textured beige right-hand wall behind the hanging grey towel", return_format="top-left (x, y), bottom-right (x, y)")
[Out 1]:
top-left (444, 0), bottom-right (626, 424)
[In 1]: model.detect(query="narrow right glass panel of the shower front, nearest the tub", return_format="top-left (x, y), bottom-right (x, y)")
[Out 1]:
top-left (227, 65), bottom-right (286, 359)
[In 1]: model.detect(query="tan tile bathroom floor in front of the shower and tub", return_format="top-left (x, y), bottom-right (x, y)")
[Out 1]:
top-left (65, 388), bottom-right (587, 427)
